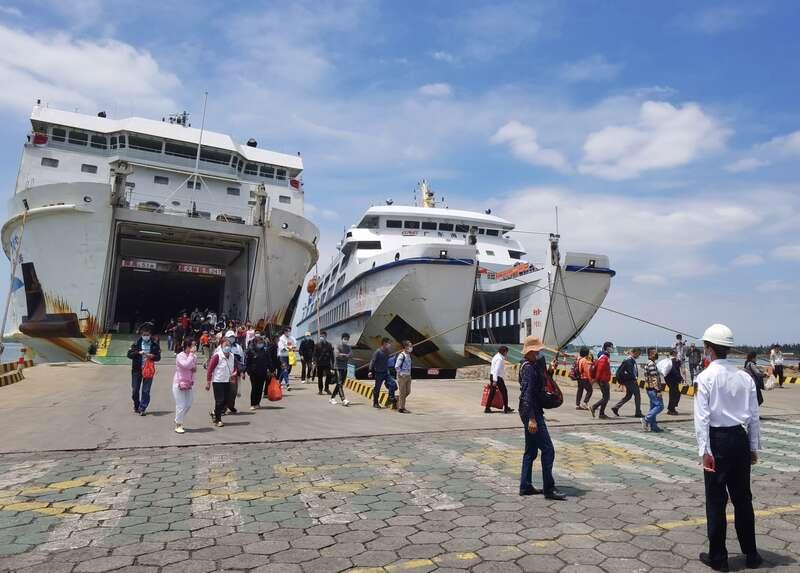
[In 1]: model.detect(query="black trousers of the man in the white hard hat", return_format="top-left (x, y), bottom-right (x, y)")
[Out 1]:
top-left (704, 426), bottom-right (757, 563)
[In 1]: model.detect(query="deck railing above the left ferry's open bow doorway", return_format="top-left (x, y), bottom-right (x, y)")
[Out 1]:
top-left (124, 190), bottom-right (253, 225)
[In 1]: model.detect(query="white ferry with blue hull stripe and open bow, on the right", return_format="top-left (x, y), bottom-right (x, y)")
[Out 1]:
top-left (294, 181), bottom-right (614, 377)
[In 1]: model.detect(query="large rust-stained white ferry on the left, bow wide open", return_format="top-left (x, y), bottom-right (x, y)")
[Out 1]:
top-left (2, 102), bottom-right (319, 360)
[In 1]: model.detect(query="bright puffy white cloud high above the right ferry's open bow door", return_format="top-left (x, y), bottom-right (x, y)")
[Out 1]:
top-left (580, 101), bottom-right (730, 180)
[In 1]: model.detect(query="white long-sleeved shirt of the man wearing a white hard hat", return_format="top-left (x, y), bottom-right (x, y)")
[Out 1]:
top-left (694, 359), bottom-right (761, 456)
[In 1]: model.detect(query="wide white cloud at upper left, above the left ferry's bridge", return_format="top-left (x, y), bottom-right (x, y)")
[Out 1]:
top-left (0, 24), bottom-right (180, 115)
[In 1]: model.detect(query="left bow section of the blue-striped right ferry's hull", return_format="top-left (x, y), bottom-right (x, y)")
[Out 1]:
top-left (296, 245), bottom-right (475, 378)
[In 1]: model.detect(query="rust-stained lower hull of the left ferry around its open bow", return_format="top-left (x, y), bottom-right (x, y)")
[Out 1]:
top-left (1, 183), bottom-right (318, 361)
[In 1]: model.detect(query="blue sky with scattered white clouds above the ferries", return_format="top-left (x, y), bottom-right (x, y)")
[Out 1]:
top-left (0, 0), bottom-right (800, 344)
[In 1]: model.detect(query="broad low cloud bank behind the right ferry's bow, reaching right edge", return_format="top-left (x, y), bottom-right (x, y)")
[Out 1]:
top-left (496, 187), bottom-right (800, 289)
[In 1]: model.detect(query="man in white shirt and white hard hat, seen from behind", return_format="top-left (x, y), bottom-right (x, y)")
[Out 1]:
top-left (694, 324), bottom-right (763, 571)
